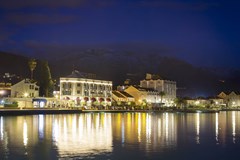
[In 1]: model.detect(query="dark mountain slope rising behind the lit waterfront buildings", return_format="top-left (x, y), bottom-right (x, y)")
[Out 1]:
top-left (0, 49), bottom-right (240, 97)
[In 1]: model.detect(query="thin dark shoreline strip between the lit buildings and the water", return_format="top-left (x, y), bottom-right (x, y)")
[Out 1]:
top-left (0, 108), bottom-right (234, 116)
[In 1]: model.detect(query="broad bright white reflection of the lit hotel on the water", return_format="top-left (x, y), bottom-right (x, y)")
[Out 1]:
top-left (53, 114), bottom-right (112, 156)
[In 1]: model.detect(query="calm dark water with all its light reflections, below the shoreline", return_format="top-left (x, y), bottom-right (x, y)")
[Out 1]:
top-left (0, 112), bottom-right (240, 160)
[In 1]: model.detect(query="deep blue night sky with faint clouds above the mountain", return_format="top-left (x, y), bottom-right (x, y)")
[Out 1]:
top-left (0, 0), bottom-right (240, 68)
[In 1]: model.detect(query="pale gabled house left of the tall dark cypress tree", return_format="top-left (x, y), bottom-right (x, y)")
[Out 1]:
top-left (11, 79), bottom-right (39, 98)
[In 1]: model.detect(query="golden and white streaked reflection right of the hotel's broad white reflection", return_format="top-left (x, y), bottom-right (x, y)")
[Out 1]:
top-left (112, 113), bottom-right (177, 151)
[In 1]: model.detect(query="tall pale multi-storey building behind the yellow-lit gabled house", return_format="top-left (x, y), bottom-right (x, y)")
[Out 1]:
top-left (140, 73), bottom-right (177, 106)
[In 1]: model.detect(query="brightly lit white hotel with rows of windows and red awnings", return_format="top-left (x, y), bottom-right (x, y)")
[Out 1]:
top-left (60, 70), bottom-right (112, 106)
